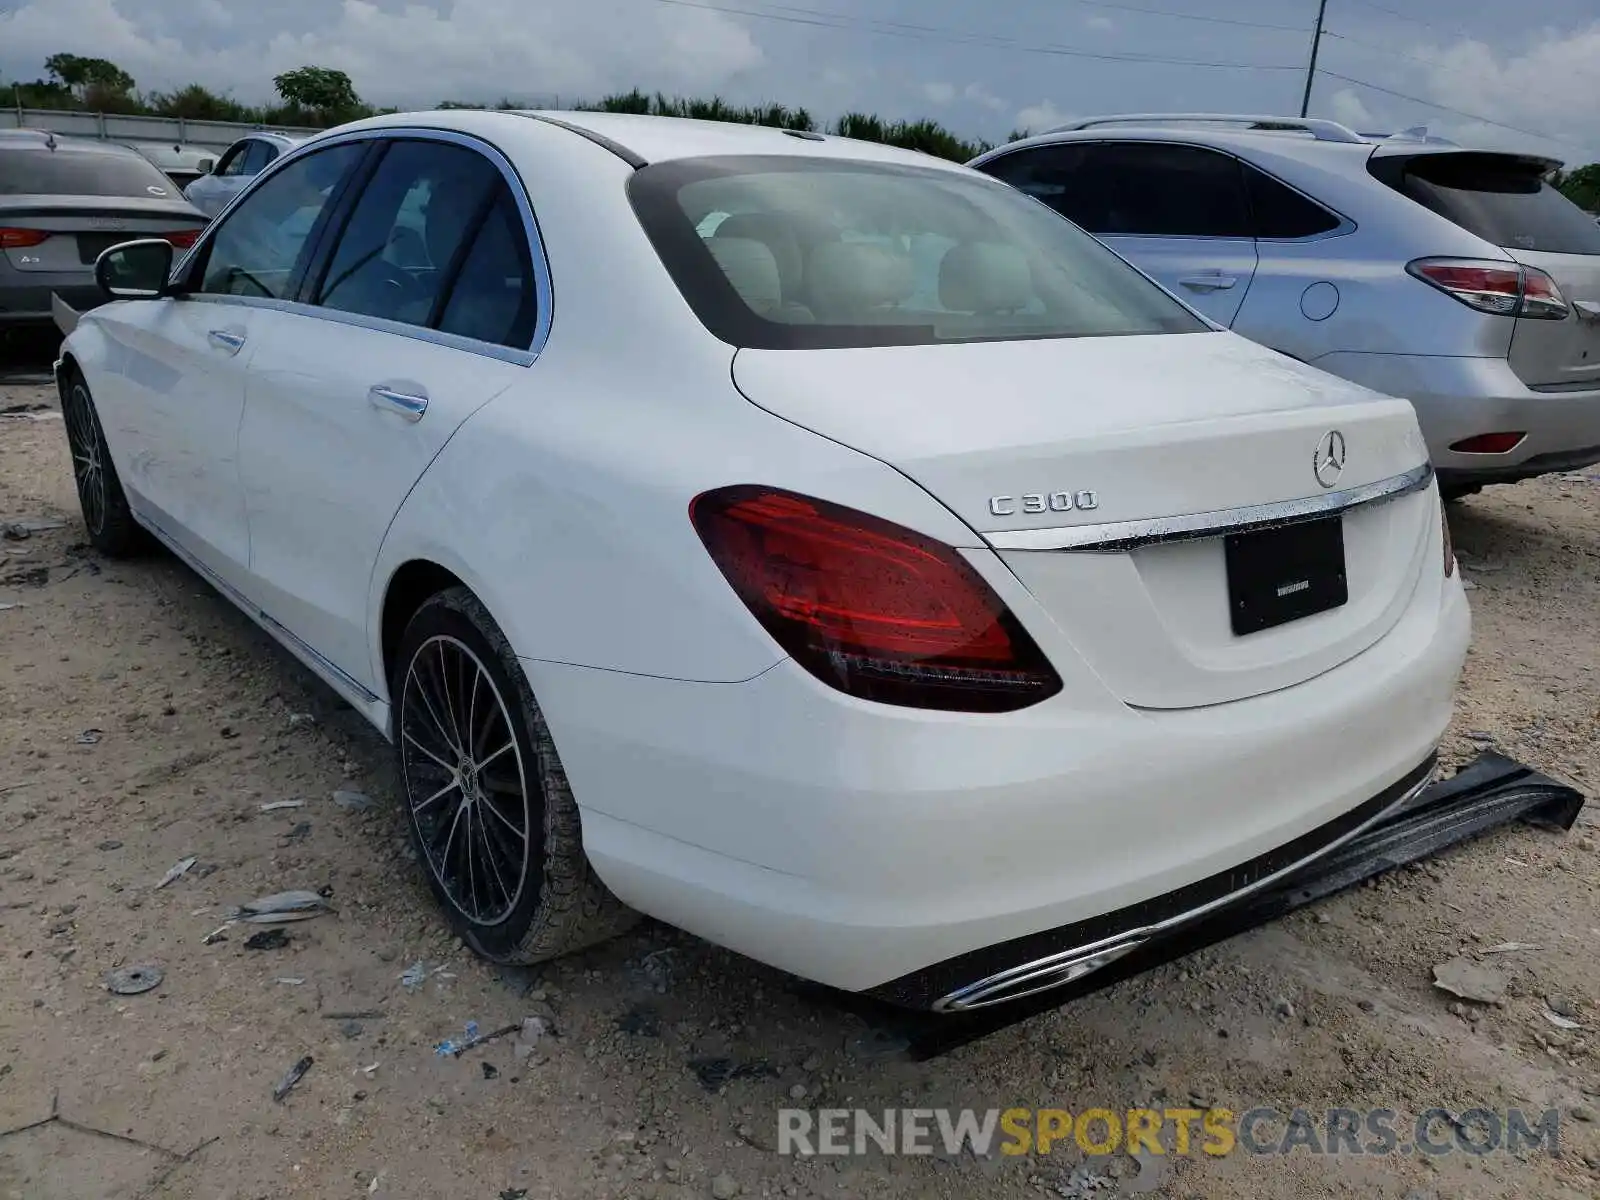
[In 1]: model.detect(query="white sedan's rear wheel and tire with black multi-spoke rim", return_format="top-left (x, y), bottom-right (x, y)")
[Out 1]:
top-left (390, 587), bottom-right (638, 963)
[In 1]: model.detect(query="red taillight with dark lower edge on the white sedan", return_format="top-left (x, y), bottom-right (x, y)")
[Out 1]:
top-left (690, 485), bottom-right (1061, 712)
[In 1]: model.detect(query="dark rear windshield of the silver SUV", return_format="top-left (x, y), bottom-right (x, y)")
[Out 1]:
top-left (1374, 154), bottom-right (1600, 254)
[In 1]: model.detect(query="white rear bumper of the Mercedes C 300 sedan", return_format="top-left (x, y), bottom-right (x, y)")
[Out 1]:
top-left (537, 569), bottom-right (1470, 1003)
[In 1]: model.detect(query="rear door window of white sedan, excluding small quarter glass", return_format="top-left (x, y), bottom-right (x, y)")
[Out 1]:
top-left (315, 141), bottom-right (510, 325)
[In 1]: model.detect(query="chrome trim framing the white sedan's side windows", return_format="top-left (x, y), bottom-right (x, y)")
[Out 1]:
top-left (173, 125), bottom-right (554, 366)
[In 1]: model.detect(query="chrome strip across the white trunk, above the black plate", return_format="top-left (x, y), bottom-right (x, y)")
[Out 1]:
top-left (981, 462), bottom-right (1434, 554)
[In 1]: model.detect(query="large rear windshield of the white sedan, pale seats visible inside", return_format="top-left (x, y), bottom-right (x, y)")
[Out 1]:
top-left (629, 157), bottom-right (1210, 349)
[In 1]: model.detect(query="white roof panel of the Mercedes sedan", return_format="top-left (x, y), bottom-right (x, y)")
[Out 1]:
top-left (307, 109), bottom-right (963, 171)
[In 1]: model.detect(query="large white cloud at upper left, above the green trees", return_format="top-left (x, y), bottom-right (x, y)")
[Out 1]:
top-left (0, 0), bottom-right (766, 107)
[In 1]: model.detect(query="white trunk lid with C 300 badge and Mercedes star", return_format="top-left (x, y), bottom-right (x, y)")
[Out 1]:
top-left (733, 333), bottom-right (1438, 709)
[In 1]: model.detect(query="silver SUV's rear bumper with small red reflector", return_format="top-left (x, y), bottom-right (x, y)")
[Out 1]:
top-left (1314, 354), bottom-right (1600, 485)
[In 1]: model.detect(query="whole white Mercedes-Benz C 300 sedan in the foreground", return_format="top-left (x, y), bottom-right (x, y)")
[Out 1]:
top-left (58, 112), bottom-right (1469, 1011)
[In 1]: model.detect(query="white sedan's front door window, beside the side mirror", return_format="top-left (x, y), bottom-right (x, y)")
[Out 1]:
top-left (198, 142), bottom-right (365, 299)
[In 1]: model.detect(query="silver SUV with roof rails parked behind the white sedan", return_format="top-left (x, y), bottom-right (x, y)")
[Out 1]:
top-left (971, 114), bottom-right (1600, 496)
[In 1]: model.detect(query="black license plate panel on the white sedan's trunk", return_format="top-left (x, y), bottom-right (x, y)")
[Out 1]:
top-left (1222, 514), bottom-right (1350, 637)
